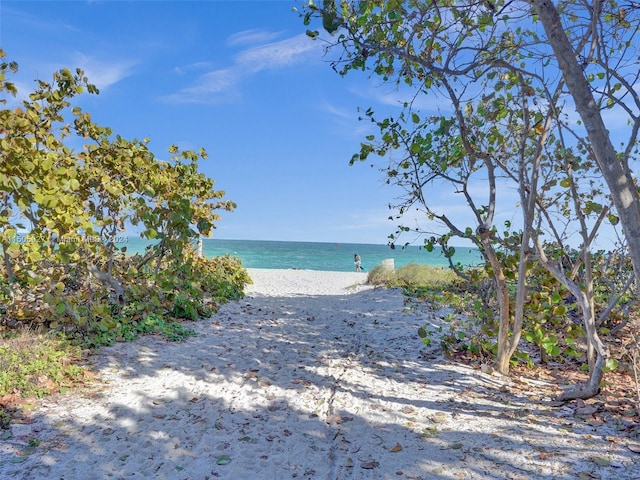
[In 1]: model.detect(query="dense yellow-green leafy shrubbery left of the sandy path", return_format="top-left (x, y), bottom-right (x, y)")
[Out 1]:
top-left (0, 51), bottom-right (250, 345)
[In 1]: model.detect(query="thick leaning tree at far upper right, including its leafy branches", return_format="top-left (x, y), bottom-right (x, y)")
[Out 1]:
top-left (531, 0), bottom-right (640, 292)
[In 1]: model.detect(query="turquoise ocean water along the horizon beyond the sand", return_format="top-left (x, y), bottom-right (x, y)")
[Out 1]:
top-left (120, 237), bottom-right (482, 272)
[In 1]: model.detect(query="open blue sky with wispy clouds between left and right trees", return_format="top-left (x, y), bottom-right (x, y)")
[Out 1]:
top-left (0, 0), bottom-right (444, 244)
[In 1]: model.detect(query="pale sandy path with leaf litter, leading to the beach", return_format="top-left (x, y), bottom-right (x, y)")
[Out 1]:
top-left (0, 269), bottom-right (640, 480)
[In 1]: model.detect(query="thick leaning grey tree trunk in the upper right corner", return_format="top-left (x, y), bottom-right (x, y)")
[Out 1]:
top-left (532, 0), bottom-right (640, 293)
